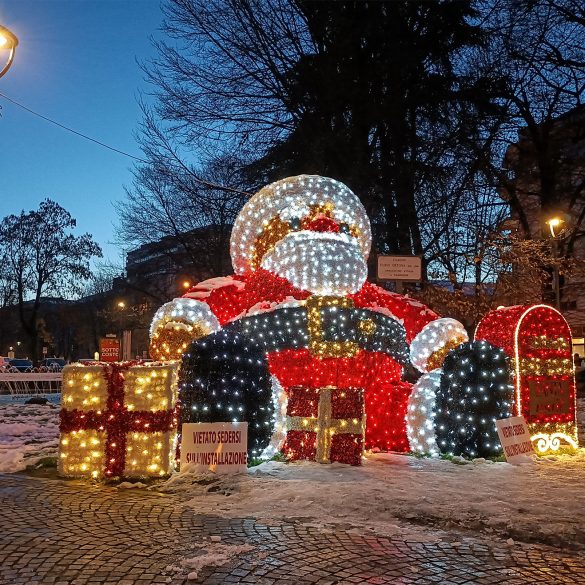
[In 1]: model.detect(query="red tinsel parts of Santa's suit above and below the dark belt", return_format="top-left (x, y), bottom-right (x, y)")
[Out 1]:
top-left (184, 269), bottom-right (439, 451)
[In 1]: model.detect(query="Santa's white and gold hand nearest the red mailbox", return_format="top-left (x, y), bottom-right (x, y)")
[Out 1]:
top-left (410, 318), bottom-right (469, 372)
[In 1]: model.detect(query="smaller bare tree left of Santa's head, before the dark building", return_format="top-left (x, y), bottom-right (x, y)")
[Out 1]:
top-left (117, 147), bottom-right (246, 282)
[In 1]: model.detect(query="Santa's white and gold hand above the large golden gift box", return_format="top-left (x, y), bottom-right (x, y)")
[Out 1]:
top-left (149, 298), bottom-right (221, 361)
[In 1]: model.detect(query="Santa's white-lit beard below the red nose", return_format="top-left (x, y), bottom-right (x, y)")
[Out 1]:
top-left (260, 231), bottom-right (368, 296)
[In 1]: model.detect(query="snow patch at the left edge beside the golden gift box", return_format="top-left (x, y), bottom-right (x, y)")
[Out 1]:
top-left (0, 404), bottom-right (59, 472)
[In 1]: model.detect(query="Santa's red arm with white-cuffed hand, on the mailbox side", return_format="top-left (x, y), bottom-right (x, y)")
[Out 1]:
top-left (354, 283), bottom-right (468, 372)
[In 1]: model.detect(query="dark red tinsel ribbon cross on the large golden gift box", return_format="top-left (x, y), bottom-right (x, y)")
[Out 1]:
top-left (59, 362), bottom-right (177, 477)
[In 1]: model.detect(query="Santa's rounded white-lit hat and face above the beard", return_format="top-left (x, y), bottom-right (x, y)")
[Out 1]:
top-left (230, 175), bottom-right (372, 274)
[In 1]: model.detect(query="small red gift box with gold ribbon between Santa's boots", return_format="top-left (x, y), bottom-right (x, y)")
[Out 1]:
top-left (285, 386), bottom-right (365, 464)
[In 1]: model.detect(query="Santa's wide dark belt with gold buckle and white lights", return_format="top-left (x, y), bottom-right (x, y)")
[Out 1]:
top-left (233, 296), bottom-right (409, 364)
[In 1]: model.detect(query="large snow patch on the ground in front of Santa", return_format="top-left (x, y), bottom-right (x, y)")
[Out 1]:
top-left (162, 442), bottom-right (585, 547)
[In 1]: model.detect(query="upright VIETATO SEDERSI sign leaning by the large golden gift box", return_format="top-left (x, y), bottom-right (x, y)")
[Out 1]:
top-left (181, 422), bottom-right (248, 473)
